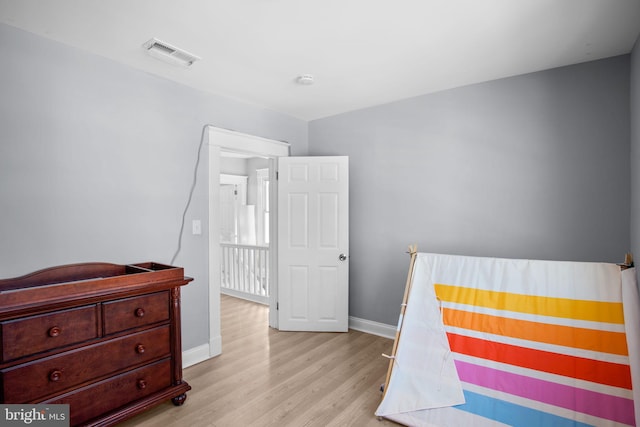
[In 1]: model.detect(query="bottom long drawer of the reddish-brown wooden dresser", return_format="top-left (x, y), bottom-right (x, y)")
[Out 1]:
top-left (46, 359), bottom-right (171, 425)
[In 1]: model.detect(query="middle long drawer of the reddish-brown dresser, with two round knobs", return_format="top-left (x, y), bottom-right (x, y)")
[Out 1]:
top-left (0, 326), bottom-right (170, 403)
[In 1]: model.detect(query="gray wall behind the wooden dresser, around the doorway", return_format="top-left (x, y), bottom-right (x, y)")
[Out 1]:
top-left (0, 25), bottom-right (307, 349)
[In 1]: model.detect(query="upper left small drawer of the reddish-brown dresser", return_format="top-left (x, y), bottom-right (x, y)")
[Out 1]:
top-left (0, 305), bottom-right (98, 362)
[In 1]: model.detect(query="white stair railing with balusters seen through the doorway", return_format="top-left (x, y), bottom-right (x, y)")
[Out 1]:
top-left (220, 243), bottom-right (269, 304)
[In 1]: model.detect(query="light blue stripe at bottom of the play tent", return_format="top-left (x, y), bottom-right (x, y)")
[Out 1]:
top-left (454, 390), bottom-right (593, 427)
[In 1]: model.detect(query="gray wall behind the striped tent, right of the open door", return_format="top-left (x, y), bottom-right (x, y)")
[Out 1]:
top-left (309, 56), bottom-right (630, 324)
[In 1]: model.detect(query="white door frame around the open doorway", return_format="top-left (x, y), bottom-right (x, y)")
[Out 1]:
top-left (207, 126), bottom-right (290, 357)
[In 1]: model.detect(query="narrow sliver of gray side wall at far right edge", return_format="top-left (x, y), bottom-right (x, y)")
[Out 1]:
top-left (630, 38), bottom-right (640, 265)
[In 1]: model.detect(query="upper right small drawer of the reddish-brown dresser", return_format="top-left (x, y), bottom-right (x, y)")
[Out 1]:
top-left (102, 292), bottom-right (169, 335)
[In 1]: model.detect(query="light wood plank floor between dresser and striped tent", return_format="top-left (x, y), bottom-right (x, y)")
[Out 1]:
top-left (121, 295), bottom-right (396, 427)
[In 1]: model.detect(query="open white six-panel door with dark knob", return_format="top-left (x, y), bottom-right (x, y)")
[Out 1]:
top-left (278, 156), bottom-right (349, 332)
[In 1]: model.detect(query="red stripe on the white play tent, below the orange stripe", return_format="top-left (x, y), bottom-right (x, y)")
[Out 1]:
top-left (447, 333), bottom-right (632, 390)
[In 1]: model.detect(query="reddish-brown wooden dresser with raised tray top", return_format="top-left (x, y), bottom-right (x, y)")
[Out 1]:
top-left (0, 263), bottom-right (192, 426)
